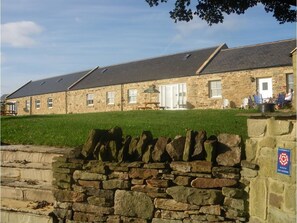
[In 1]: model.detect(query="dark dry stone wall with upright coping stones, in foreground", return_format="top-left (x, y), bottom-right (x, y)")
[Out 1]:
top-left (53, 127), bottom-right (250, 223)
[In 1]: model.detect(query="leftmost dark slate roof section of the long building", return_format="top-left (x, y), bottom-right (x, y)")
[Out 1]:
top-left (7, 70), bottom-right (89, 99)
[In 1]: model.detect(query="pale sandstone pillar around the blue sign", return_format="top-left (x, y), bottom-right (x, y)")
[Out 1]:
top-left (242, 114), bottom-right (296, 223)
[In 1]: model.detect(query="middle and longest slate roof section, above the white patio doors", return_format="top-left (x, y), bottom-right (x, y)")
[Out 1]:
top-left (71, 47), bottom-right (218, 90)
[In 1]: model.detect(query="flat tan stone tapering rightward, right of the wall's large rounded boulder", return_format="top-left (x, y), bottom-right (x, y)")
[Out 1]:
top-left (154, 198), bottom-right (200, 211)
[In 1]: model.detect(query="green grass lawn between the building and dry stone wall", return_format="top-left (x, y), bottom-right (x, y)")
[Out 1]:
top-left (1, 109), bottom-right (254, 147)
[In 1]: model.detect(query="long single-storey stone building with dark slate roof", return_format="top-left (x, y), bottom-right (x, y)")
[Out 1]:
top-left (7, 39), bottom-right (296, 115)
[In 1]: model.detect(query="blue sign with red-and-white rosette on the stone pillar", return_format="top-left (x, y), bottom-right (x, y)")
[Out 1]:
top-left (277, 148), bottom-right (291, 175)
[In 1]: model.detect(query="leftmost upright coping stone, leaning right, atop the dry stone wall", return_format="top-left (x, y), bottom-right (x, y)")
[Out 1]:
top-left (81, 129), bottom-right (108, 158)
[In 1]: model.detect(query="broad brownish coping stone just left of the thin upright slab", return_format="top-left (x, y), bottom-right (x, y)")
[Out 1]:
top-left (166, 136), bottom-right (186, 161)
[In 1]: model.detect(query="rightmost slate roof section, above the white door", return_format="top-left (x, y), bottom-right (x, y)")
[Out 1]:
top-left (200, 39), bottom-right (296, 74)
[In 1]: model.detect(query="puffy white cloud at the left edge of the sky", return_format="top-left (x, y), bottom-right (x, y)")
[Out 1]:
top-left (1, 21), bottom-right (43, 47)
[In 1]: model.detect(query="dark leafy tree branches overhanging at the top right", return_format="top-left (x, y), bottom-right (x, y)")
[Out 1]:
top-left (146, 0), bottom-right (296, 25)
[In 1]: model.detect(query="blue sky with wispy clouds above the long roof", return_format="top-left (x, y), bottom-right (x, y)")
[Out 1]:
top-left (1, 0), bottom-right (296, 94)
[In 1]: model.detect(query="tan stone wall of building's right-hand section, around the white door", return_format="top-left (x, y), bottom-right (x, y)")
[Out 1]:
top-left (194, 66), bottom-right (293, 108)
